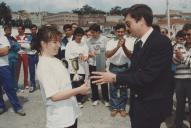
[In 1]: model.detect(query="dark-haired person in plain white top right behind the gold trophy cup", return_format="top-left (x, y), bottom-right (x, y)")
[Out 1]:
top-left (65, 27), bottom-right (88, 107)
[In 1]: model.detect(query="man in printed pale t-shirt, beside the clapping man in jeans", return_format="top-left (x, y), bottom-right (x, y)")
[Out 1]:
top-left (87, 24), bottom-right (109, 106)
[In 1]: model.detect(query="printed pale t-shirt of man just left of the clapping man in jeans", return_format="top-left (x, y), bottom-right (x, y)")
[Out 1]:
top-left (87, 35), bottom-right (109, 66)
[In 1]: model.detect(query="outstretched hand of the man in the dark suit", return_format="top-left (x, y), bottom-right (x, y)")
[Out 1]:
top-left (90, 72), bottom-right (116, 84)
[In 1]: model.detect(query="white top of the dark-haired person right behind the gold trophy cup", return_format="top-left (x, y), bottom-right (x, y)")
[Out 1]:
top-left (65, 40), bottom-right (88, 74)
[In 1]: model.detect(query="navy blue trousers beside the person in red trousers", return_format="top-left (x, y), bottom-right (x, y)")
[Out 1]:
top-left (28, 55), bottom-right (38, 88)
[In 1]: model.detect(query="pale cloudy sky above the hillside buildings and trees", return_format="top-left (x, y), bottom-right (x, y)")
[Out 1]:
top-left (0, 0), bottom-right (191, 14)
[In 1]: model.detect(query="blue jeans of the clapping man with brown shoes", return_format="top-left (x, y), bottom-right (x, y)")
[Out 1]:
top-left (109, 64), bottom-right (128, 110)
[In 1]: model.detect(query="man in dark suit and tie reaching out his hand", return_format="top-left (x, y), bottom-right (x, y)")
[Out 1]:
top-left (91, 4), bottom-right (173, 128)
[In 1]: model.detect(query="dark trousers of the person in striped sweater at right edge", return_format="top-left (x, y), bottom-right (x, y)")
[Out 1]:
top-left (175, 79), bottom-right (191, 128)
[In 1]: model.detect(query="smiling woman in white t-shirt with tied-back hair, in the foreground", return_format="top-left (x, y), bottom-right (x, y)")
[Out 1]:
top-left (34, 26), bottom-right (89, 128)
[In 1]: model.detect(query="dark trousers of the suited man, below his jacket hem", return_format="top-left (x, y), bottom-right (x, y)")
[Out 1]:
top-left (129, 98), bottom-right (169, 128)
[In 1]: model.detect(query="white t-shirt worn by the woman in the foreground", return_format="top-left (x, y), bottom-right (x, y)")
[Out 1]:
top-left (37, 56), bottom-right (79, 128)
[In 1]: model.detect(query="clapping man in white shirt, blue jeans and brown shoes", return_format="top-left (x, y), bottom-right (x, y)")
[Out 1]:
top-left (106, 24), bottom-right (134, 117)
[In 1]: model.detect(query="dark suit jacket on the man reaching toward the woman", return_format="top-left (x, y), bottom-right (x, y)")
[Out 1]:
top-left (116, 30), bottom-right (173, 119)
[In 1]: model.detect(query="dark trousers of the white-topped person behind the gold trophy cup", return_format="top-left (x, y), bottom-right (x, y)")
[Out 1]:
top-left (70, 74), bottom-right (85, 103)
